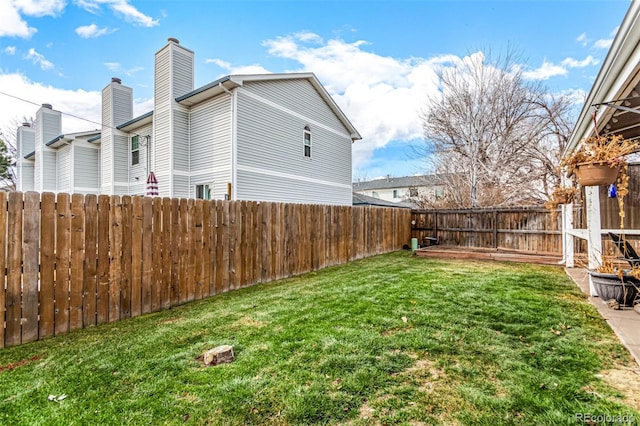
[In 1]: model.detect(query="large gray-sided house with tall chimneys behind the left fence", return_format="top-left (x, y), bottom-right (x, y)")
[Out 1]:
top-left (19, 38), bottom-right (361, 205)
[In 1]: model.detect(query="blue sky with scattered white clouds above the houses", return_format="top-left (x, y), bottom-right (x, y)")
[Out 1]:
top-left (0, 0), bottom-right (630, 179)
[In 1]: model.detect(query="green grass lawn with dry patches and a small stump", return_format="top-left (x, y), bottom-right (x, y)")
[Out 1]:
top-left (0, 252), bottom-right (640, 425)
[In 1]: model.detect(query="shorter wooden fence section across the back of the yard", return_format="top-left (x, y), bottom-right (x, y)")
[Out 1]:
top-left (411, 207), bottom-right (562, 254)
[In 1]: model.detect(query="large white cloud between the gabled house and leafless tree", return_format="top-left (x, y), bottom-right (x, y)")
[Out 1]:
top-left (264, 32), bottom-right (440, 169)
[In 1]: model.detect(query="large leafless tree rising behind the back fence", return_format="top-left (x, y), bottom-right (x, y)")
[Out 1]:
top-left (422, 51), bottom-right (572, 207)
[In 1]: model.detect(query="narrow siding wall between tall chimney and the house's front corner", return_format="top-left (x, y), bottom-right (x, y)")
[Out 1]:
top-left (190, 95), bottom-right (231, 198)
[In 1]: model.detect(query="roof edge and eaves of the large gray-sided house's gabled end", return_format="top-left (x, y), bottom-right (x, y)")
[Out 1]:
top-left (175, 72), bottom-right (362, 141)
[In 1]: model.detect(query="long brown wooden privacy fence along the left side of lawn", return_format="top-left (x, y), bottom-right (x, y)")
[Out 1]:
top-left (0, 192), bottom-right (410, 347)
